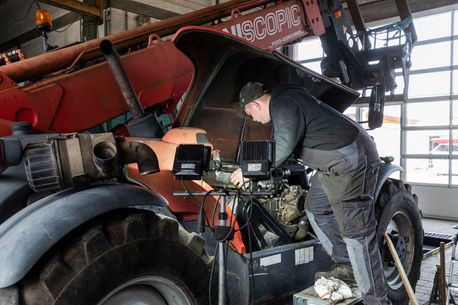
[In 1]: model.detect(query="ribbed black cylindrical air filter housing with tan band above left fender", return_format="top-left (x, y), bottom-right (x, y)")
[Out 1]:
top-left (22, 133), bottom-right (159, 192)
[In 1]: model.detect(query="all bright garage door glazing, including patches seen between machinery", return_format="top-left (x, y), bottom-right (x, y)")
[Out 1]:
top-left (298, 10), bottom-right (458, 186)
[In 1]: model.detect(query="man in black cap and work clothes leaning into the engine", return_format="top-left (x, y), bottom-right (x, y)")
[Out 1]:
top-left (231, 82), bottom-right (391, 305)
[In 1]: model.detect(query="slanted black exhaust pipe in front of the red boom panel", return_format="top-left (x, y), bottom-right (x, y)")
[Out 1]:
top-left (100, 39), bottom-right (145, 119)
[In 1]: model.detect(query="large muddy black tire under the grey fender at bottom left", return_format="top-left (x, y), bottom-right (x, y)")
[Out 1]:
top-left (17, 210), bottom-right (211, 305)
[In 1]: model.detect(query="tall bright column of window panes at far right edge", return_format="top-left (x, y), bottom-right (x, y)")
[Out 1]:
top-left (401, 10), bottom-right (458, 186)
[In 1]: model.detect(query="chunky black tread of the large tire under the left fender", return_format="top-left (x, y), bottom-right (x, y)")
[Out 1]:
top-left (19, 210), bottom-right (211, 305)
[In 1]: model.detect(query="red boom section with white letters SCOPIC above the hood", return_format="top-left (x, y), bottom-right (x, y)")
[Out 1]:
top-left (212, 1), bottom-right (309, 49)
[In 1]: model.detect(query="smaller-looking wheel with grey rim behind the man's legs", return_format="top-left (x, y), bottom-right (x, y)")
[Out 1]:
top-left (376, 179), bottom-right (423, 305)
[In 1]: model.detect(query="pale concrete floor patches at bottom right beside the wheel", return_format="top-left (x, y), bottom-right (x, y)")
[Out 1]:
top-left (415, 218), bottom-right (458, 305)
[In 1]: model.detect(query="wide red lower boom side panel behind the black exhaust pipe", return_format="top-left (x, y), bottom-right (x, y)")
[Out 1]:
top-left (0, 42), bottom-right (192, 134)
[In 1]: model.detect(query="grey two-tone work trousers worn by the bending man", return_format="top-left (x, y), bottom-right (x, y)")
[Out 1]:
top-left (303, 130), bottom-right (391, 305)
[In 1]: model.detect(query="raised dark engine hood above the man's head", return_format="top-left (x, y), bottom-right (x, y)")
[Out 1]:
top-left (173, 26), bottom-right (359, 159)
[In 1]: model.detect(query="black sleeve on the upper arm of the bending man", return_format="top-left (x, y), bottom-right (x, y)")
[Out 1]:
top-left (270, 95), bottom-right (306, 167)
